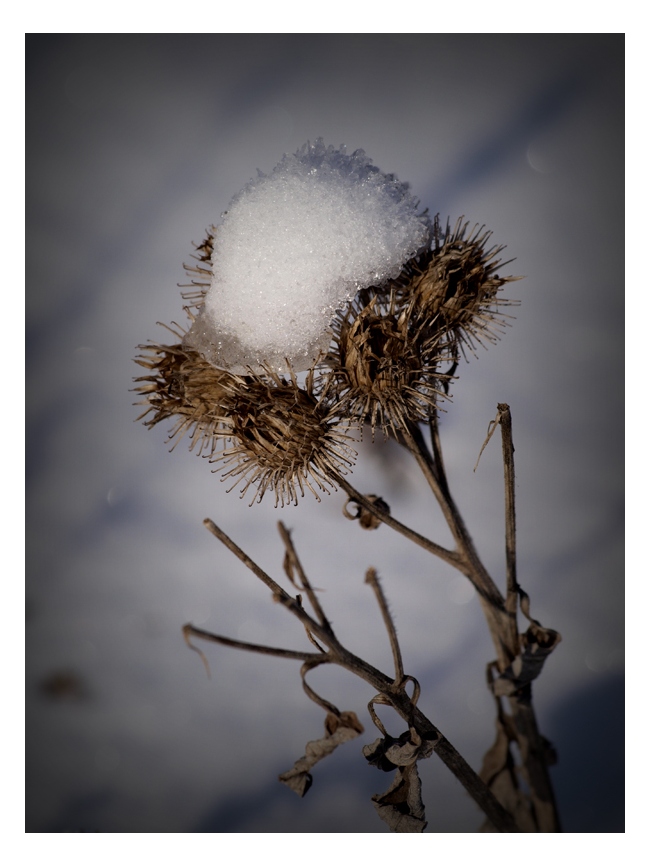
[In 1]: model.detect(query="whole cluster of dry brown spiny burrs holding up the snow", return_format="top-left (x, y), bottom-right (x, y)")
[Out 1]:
top-left (136, 207), bottom-right (517, 506)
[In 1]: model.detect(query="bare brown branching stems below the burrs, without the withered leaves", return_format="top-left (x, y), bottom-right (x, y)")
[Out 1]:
top-left (192, 414), bottom-right (559, 831)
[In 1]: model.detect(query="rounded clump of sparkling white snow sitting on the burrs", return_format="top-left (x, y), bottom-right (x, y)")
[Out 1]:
top-left (186, 139), bottom-right (430, 373)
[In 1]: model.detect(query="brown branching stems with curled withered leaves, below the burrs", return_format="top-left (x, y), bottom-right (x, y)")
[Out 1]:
top-left (183, 404), bottom-right (561, 833)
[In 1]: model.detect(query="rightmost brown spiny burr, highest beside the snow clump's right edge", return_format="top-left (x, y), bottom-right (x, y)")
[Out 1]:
top-left (396, 217), bottom-right (520, 360)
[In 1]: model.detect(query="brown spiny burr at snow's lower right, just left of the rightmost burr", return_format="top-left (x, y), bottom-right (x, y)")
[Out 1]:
top-left (323, 294), bottom-right (445, 437)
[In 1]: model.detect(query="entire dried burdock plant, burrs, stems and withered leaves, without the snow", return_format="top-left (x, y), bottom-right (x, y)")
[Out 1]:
top-left (136, 219), bottom-right (560, 832)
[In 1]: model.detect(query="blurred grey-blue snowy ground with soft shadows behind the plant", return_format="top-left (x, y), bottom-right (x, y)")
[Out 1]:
top-left (26, 35), bottom-right (624, 833)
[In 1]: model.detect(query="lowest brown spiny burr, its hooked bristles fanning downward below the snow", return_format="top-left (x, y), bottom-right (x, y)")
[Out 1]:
top-left (215, 368), bottom-right (356, 506)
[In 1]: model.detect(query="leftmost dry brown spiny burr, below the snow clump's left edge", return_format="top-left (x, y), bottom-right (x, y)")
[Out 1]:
top-left (134, 328), bottom-right (241, 456)
